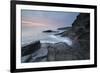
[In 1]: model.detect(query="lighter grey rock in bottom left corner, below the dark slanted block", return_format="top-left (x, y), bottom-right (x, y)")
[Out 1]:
top-left (21, 44), bottom-right (48, 63)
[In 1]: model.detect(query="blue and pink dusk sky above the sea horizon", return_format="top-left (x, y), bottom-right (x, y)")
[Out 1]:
top-left (21, 10), bottom-right (79, 29)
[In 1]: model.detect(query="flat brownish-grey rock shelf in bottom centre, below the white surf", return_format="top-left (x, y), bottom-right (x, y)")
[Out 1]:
top-left (47, 42), bottom-right (87, 61)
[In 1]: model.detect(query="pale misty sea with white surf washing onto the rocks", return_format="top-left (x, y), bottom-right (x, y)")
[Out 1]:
top-left (22, 30), bottom-right (72, 46)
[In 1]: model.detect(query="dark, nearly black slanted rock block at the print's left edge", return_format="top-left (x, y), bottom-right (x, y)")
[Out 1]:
top-left (21, 41), bottom-right (41, 56)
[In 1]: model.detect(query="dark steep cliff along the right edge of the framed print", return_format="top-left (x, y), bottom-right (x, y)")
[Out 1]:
top-left (62, 13), bottom-right (90, 58)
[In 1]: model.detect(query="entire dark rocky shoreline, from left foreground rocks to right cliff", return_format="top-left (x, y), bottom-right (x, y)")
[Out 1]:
top-left (21, 13), bottom-right (90, 63)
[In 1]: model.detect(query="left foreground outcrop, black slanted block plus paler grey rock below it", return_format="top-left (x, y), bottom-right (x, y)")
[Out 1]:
top-left (21, 41), bottom-right (50, 63)
